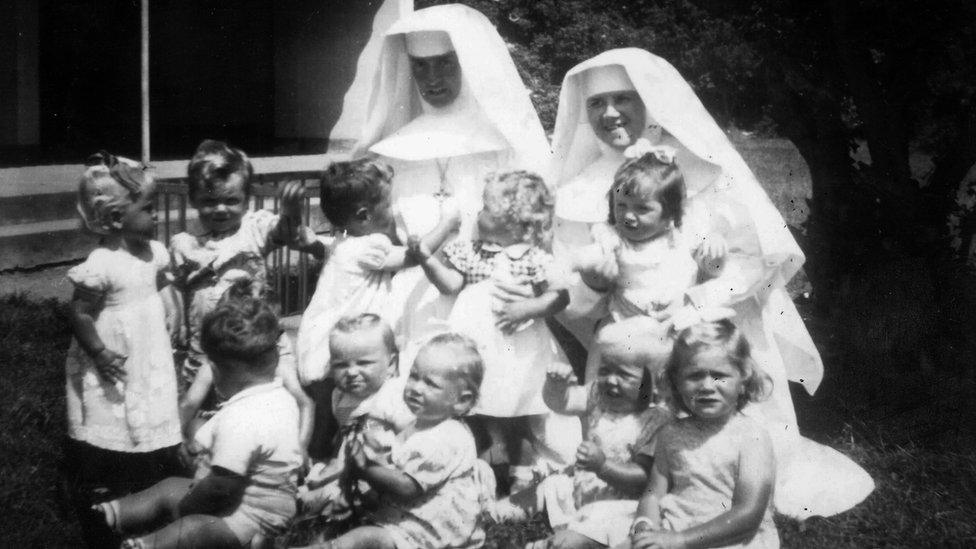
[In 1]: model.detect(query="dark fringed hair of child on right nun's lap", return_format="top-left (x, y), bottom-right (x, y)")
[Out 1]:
top-left (607, 153), bottom-right (686, 228)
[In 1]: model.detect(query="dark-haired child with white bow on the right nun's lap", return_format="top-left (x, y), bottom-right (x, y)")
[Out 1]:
top-left (577, 139), bottom-right (725, 379)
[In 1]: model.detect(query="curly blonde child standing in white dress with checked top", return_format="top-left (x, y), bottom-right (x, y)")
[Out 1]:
top-left (413, 171), bottom-right (579, 482)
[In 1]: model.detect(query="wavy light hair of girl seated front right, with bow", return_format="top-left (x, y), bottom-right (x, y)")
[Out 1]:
top-left (664, 318), bottom-right (773, 413)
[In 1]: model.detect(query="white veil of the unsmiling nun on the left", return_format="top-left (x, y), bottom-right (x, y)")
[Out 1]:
top-left (353, 4), bottom-right (550, 173)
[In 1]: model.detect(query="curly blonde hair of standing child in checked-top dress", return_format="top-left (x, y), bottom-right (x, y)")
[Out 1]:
top-left (484, 170), bottom-right (555, 250)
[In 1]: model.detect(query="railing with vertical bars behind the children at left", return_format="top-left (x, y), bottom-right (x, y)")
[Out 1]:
top-left (156, 171), bottom-right (321, 316)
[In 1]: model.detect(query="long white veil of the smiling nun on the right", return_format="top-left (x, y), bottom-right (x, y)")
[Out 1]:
top-left (549, 48), bottom-right (823, 394)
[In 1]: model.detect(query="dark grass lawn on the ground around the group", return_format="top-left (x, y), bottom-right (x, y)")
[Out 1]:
top-left (0, 142), bottom-right (976, 548)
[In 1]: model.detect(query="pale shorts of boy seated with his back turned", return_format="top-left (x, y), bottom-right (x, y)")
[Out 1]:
top-left (224, 485), bottom-right (297, 545)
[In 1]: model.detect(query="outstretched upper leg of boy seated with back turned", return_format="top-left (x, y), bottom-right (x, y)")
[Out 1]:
top-left (106, 477), bottom-right (193, 532)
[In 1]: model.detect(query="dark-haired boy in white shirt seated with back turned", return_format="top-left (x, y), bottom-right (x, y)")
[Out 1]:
top-left (99, 288), bottom-right (301, 549)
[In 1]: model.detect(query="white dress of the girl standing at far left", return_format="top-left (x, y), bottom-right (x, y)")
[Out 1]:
top-left (65, 241), bottom-right (182, 452)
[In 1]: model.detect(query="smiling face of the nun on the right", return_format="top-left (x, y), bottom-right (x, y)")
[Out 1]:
top-left (586, 90), bottom-right (647, 149)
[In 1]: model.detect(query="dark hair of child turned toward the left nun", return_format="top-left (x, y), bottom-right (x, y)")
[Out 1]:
top-left (319, 158), bottom-right (393, 229)
